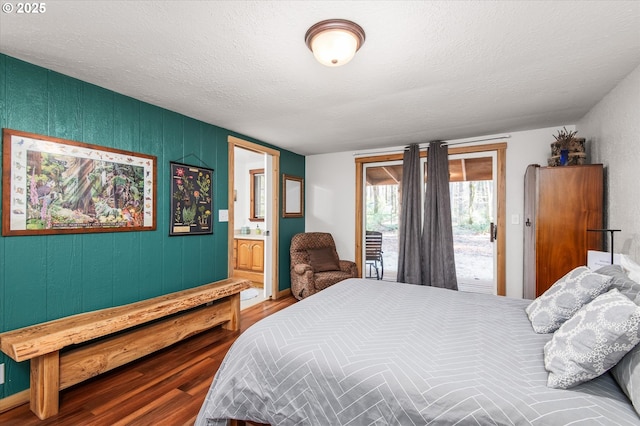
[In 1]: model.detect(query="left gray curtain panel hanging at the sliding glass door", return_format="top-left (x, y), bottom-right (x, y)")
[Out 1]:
top-left (397, 144), bottom-right (422, 284)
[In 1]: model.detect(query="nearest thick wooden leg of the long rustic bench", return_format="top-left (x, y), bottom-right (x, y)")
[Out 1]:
top-left (29, 351), bottom-right (60, 420)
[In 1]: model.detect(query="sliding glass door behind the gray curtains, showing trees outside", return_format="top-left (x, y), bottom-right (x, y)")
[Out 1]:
top-left (362, 151), bottom-right (497, 294)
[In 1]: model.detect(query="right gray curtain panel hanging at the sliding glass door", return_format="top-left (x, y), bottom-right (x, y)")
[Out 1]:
top-left (422, 141), bottom-right (458, 290)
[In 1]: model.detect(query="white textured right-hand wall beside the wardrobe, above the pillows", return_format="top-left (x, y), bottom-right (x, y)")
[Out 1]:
top-left (576, 66), bottom-right (640, 262)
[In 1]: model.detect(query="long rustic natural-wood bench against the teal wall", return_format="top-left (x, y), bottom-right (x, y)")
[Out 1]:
top-left (0, 278), bottom-right (251, 419)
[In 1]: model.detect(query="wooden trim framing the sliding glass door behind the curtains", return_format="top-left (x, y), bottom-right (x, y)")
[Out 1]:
top-left (355, 142), bottom-right (507, 296)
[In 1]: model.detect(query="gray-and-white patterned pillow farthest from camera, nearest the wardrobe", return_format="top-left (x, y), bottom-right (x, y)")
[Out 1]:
top-left (526, 266), bottom-right (611, 333)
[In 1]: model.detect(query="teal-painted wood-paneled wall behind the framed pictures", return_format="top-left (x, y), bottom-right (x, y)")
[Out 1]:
top-left (0, 54), bottom-right (304, 398)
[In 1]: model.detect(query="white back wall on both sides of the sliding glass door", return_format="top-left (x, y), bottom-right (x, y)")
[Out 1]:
top-left (305, 126), bottom-right (574, 297)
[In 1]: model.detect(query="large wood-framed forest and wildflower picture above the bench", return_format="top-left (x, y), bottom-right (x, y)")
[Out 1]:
top-left (2, 128), bottom-right (157, 236)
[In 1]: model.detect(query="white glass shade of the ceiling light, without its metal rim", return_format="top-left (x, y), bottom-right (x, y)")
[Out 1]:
top-left (311, 30), bottom-right (358, 67)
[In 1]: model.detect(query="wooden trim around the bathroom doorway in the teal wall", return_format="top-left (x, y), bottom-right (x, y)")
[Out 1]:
top-left (227, 136), bottom-right (280, 300)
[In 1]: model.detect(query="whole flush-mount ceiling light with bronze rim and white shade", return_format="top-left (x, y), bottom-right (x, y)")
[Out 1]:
top-left (304, 19), bottom-right (364, 67)
